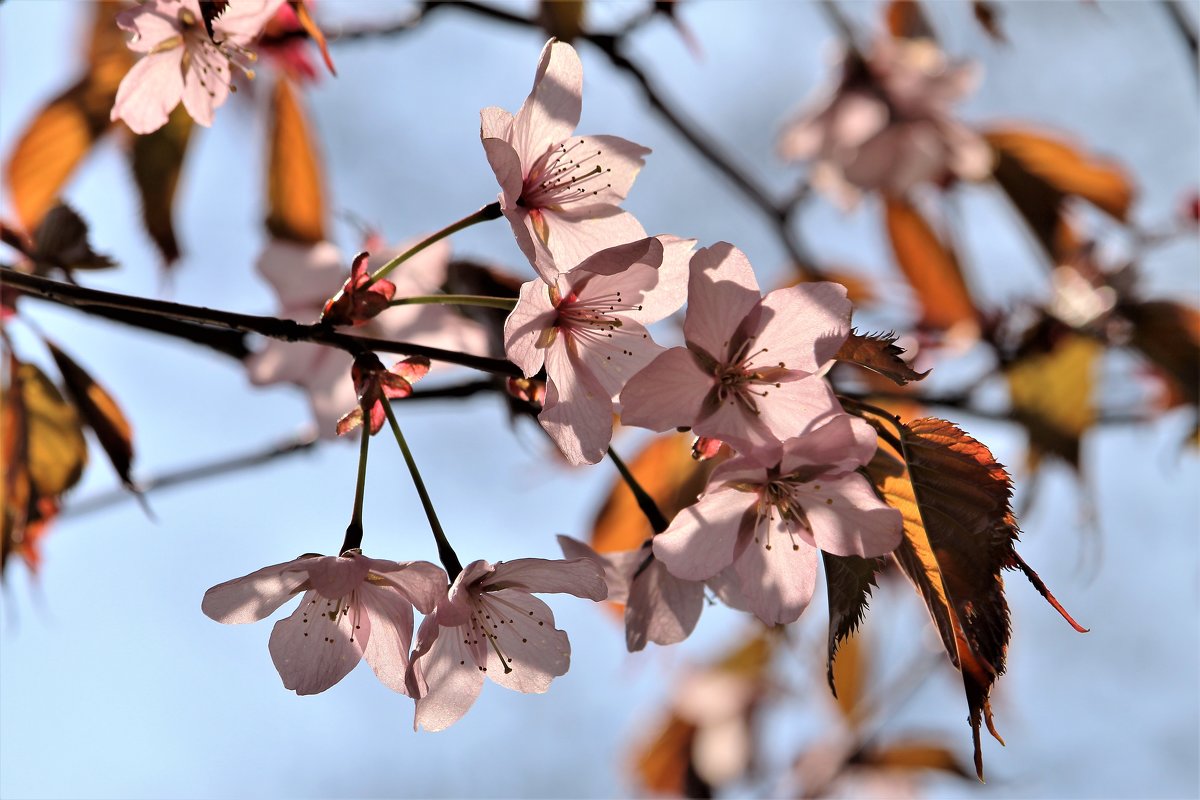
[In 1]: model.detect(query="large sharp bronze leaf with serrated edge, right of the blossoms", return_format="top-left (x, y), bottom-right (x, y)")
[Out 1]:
top-left (868, 419), bottom-right (1082, 780)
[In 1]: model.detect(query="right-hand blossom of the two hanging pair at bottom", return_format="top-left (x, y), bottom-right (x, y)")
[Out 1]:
top-left (408, 559), bottom-right (608, 730)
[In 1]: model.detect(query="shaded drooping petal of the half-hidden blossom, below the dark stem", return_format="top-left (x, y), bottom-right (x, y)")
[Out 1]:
top-left (625, 561), bottom-right (704, 652)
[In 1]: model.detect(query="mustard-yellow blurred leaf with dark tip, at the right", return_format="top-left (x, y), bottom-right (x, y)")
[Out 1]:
top-left (1004, 332), bottom-right (1104, 469)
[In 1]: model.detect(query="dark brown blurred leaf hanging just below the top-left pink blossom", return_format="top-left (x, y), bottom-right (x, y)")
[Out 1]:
top-left (130, 106), bottom-right (193, 266)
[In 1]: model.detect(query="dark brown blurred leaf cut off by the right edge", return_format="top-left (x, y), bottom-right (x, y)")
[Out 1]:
top-left (1120, 300), bottom-right (1200, 405)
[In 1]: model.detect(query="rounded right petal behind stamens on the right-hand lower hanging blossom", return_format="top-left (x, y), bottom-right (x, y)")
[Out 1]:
top-left (479, 587), bottom-right (568, 694)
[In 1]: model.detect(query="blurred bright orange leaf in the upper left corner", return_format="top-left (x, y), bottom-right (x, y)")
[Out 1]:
top-left (4, 2), bottom-right (133, 230)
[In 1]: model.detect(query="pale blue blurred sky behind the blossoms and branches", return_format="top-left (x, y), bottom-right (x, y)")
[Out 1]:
top-left (0, 0), bottom-right (1200, 798)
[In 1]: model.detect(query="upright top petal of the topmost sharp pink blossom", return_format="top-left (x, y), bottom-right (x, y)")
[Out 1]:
top-left (512, 40), bottom-right (583, 168)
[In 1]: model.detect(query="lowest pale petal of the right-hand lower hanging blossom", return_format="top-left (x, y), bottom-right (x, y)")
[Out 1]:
top-left (410, 616), bottom-right (486, 730)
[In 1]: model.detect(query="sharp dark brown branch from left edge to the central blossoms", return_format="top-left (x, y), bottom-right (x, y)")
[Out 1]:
top-left (0, 270), bottom-right (521, 377)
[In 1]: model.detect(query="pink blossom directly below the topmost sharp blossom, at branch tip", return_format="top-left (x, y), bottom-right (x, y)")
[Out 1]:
top-left (504, 236), bottom-right (695, 464)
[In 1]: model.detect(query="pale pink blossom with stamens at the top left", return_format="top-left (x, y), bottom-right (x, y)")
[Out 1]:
top-left (110, 0), bottom-right (283, 133)
